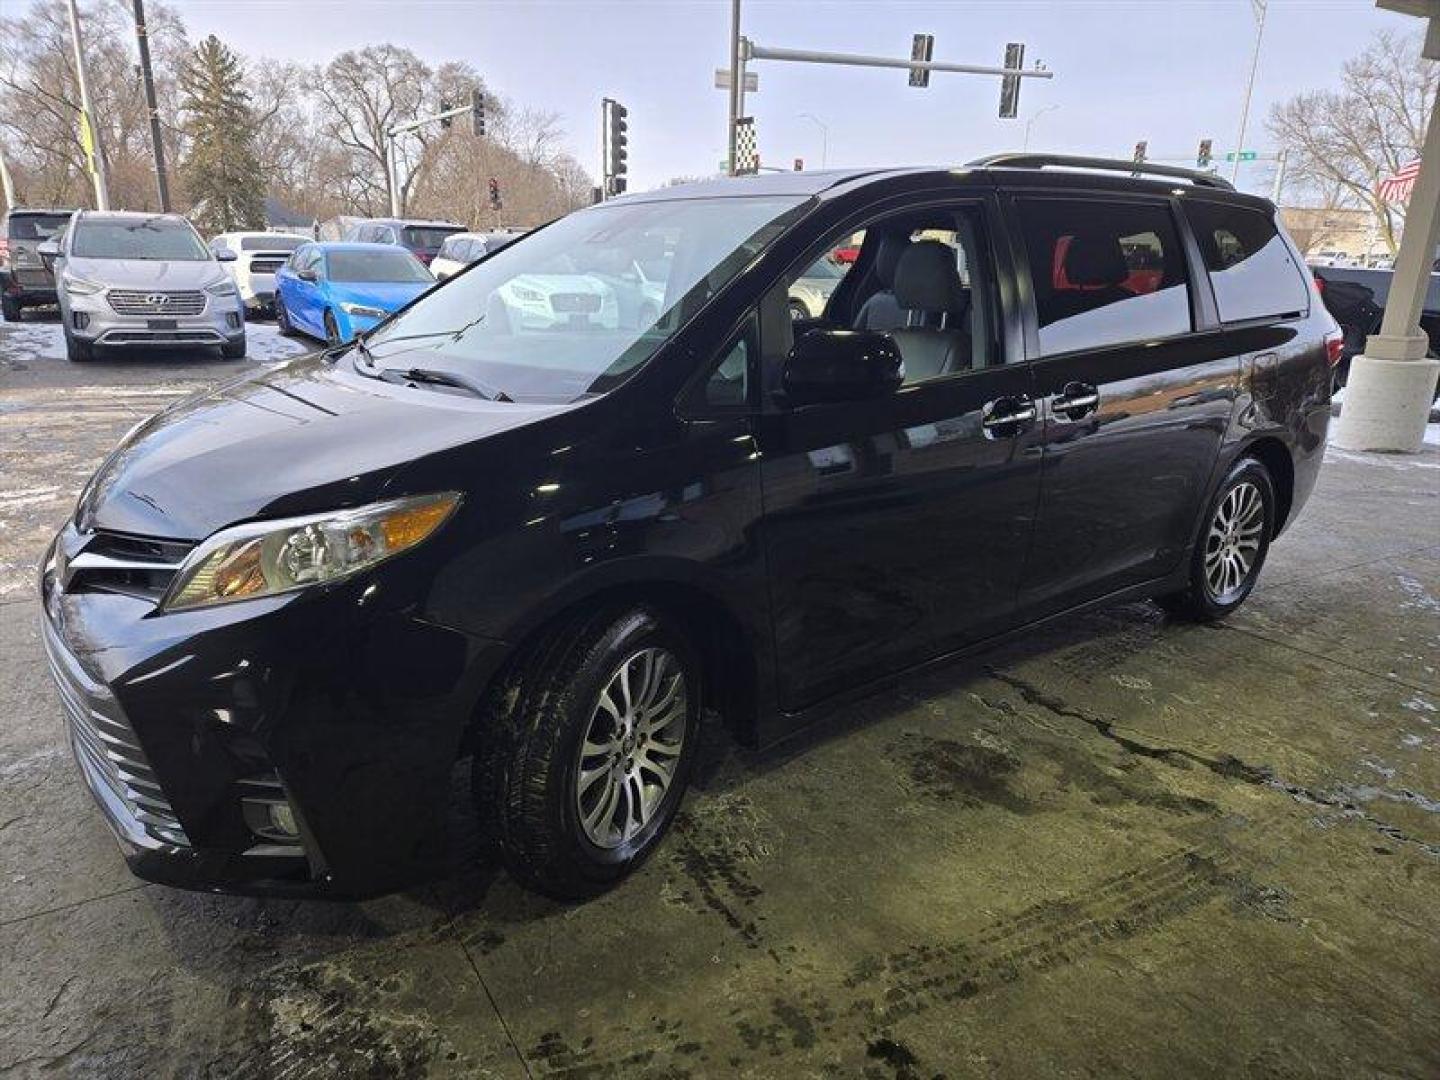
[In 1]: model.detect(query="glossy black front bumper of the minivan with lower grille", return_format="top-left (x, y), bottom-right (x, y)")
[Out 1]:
top-left (40, 524), bottom-right (507, 899)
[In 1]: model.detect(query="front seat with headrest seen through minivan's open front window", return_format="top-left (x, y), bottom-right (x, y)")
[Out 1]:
top-left (890, 240), bottom-right (971, 383)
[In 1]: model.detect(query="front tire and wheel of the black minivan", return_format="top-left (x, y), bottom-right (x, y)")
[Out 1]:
top-left (474, 606), bottom-right (701, 900)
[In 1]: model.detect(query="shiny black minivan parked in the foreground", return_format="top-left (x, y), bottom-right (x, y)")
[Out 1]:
top-left (40, 156), bottom-right (1341, 897)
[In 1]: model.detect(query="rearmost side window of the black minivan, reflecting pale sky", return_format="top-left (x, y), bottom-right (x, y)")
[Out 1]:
top-left (1185, 202), bottom-right (1310, 323)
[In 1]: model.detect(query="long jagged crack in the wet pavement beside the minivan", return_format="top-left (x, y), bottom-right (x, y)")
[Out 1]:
top-left (986, 668), bottom-right (1440, 858)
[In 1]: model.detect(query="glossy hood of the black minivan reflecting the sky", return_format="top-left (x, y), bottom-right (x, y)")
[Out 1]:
top-left (76, 354), bottom-right (573, 540)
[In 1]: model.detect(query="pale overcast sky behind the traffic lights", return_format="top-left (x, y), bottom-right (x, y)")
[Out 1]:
top-left (50, 0), bottom-right (1418, 190)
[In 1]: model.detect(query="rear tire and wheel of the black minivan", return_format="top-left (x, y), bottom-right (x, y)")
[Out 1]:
top-left (1158, 458), bottom-right (1276, 622)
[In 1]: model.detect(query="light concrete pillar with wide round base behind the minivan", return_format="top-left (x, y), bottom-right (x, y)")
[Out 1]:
top-left (1331, 0), bottom-right (1440, 454)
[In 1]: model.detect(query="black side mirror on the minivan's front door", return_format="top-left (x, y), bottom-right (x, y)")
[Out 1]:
top-left (780, 330), bottom-right (904, 406)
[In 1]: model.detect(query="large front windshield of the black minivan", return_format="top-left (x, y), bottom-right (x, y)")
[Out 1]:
top-left (360, 196), bottom-right (809, 402)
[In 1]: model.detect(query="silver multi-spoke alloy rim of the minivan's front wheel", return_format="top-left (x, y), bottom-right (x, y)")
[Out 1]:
top-left (575, 648), bottom-right (688, 848)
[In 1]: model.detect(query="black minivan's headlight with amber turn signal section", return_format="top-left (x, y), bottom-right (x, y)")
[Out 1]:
top-left (160, 491), bottom-right (459, 611)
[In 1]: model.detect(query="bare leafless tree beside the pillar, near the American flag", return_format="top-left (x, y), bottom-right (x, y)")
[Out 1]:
top-left (1267, 32), bottom-right (1440, 252)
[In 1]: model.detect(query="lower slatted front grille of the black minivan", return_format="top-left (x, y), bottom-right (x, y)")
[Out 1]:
top-left (45, 622), bottom-right (190, 847)
